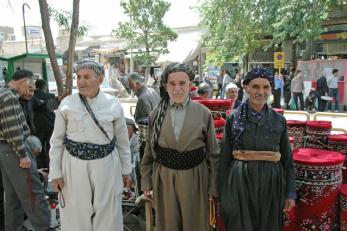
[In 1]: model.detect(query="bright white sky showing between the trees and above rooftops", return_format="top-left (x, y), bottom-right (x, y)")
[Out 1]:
top-left (0, 0), bottom-right (199, 39)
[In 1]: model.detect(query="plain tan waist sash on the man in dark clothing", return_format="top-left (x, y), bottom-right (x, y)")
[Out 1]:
top-left (233, 150), bottom-right (281, 162)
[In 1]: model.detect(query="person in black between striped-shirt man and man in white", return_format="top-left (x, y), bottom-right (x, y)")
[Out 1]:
top-left (33, 79), bottom-right (59, 168)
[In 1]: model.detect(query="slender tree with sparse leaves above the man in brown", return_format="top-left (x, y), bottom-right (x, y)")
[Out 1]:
top-left (113, 0), bottom-right (177, 81)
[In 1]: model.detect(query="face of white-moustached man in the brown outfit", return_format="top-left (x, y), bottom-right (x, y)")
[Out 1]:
top-left (165, 72), bottom-right (192, 104)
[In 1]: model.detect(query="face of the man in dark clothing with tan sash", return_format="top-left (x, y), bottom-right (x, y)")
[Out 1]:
top-left (245, 78), bottom-right (271, 106)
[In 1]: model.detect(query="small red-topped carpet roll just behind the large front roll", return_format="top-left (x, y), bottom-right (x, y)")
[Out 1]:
top-left (306, 121), bottom-right (332, 149)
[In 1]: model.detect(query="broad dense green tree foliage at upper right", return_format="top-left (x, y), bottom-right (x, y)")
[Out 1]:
top-left (200, 0), bottom-right (346, 65)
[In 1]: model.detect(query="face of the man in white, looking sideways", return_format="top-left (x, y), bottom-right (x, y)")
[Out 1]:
top-left (76, 69), bottom-right (104, 98)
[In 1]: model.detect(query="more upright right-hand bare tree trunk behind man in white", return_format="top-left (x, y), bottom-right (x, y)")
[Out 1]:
top-left (65, 0), bottom-right (80, 95)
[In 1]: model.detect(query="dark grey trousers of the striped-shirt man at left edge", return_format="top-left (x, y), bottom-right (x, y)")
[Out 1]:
top-left (0, 144), bottom-right (50, 231)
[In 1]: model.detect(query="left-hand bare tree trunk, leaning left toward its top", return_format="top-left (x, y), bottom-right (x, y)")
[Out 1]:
top-left (39, 0), bottom-right (64, 96)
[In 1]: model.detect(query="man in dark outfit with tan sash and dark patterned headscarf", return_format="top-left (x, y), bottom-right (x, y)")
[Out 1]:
top-left (220, 68), bottom-right (296, 231)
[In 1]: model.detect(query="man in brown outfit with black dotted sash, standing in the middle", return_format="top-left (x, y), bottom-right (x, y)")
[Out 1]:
top-left (141, 63), bottom-right (220, 231)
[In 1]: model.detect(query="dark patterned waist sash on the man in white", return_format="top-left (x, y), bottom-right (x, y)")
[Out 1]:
top-left (64, 137), bottom-right (116, 160)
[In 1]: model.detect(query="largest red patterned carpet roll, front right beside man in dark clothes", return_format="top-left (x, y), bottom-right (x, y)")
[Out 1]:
top-left (289, 148), bottom-right (345, 231)
